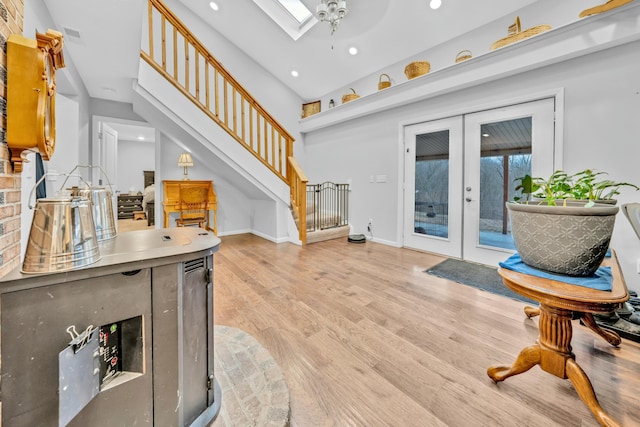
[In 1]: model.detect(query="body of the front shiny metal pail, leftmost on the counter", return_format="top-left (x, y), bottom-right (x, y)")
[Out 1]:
top-left (22, 186), bottom-right (100, 273)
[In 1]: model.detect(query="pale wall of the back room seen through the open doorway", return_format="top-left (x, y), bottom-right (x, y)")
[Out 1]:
top-left (115, 139), bottom-right (156, 193)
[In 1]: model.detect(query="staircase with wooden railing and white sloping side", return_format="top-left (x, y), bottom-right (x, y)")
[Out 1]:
top-left (133, 0), bottom-right (307, 245)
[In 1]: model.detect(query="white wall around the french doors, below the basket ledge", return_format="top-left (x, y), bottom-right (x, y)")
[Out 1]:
top-left (305, 42), bottom-right (640, 289)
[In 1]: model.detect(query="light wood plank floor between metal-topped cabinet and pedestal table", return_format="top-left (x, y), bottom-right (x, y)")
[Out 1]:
top-left (214, 235), bottom-right (640, 427)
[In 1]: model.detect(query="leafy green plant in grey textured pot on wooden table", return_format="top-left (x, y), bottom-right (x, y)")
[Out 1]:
top-left (507, 169), bottom-right (638, 276)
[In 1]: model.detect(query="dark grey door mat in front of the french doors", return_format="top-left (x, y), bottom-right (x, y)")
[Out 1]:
top-left (425, 258), bottom-right (538, 306)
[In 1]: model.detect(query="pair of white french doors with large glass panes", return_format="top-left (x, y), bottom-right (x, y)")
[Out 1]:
top-left (403, 98), bottom-right (555, 265)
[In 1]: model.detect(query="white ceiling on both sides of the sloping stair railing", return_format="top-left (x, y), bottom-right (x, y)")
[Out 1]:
top-left (40, 0), bottom-right (536, 103)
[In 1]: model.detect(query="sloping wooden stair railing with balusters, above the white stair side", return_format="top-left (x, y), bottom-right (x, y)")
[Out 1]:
top-left (140, 0), bottom-right (294, 186)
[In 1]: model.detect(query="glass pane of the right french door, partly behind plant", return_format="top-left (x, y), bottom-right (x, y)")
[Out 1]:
top-left (478, 117), bottom-right (532, 249)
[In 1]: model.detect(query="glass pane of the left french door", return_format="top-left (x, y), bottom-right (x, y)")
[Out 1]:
top-left (413, 130), bottom-right (449, 238)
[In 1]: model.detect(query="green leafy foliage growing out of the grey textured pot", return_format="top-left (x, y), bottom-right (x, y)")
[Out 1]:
top-left (513, 169), bottom-right (640, 207)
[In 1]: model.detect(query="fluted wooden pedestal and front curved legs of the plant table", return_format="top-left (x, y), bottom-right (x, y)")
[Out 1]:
top-left (487, 304), bottom-right (619, 427)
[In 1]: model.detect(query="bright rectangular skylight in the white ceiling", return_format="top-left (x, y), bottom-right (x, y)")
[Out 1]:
top-left (253, 0), bottom-right (318, 40)
